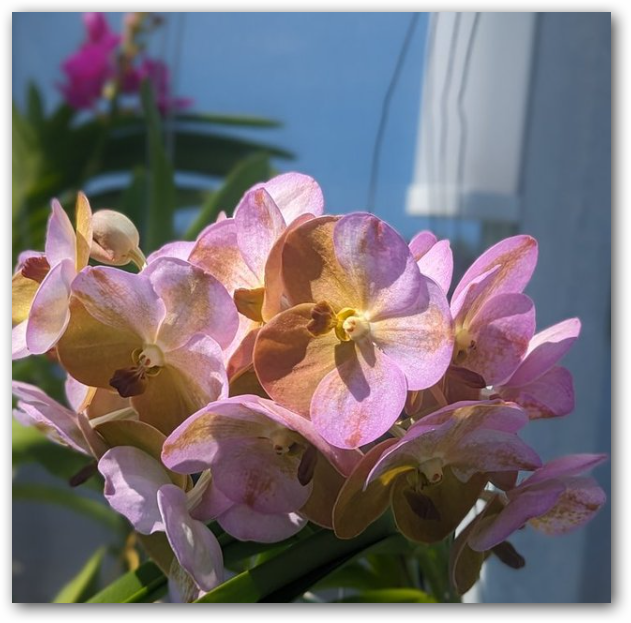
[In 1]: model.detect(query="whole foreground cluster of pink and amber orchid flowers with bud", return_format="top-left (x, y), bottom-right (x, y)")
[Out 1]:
top-left (13, 173), bottom-right (606, 600)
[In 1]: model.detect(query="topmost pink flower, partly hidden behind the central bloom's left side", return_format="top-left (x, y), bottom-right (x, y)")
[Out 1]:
top-left (186, 173), bottom-right (324, 377)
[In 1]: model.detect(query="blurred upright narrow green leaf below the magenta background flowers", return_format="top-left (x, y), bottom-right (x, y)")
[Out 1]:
top-left (140, 80), bottom-right (175, 251)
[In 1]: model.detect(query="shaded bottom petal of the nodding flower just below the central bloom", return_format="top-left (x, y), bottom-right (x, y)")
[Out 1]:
top-left (217, 504), bottom-right (307, 543)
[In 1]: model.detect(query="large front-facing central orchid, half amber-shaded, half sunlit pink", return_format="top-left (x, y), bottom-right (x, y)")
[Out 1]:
top-left (254, 213), bottom-right (453, 448)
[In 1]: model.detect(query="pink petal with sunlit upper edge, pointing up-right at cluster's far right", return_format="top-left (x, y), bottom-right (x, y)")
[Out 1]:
top-left (506, 318), bottom-right (581, 387)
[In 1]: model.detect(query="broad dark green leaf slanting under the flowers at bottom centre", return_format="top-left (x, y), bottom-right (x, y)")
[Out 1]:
top-left (198, 516), bottom-right (394, 603)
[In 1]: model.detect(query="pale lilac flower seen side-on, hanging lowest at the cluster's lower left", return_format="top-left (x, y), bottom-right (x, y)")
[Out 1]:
top-left (98, 446), bottom-right (224, 592)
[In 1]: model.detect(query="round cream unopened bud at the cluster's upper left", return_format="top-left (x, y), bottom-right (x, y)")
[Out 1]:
top-left (90, 210), bottom-right (146, 269)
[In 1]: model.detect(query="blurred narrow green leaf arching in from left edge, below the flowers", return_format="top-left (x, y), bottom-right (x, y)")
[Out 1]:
top-left (13, 483), bottom-right (127, 532)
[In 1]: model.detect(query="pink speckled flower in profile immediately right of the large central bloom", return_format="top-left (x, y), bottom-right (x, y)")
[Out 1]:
top-left (451, 236), bottom-right (537, 385)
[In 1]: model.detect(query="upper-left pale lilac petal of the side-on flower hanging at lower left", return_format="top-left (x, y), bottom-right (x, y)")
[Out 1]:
top-left (99, 446), bottom-right (170, 534)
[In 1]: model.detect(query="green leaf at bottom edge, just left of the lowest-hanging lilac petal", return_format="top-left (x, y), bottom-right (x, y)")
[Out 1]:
top-left (88, 562), bottom-right (167, 604)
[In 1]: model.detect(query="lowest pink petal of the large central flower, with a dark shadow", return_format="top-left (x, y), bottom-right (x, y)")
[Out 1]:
top-left (310, 341), bottom-right (407, 448)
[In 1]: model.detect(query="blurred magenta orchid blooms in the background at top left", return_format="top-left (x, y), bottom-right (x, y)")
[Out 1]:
top-left (59, 13), bottom-right (192, 114)
